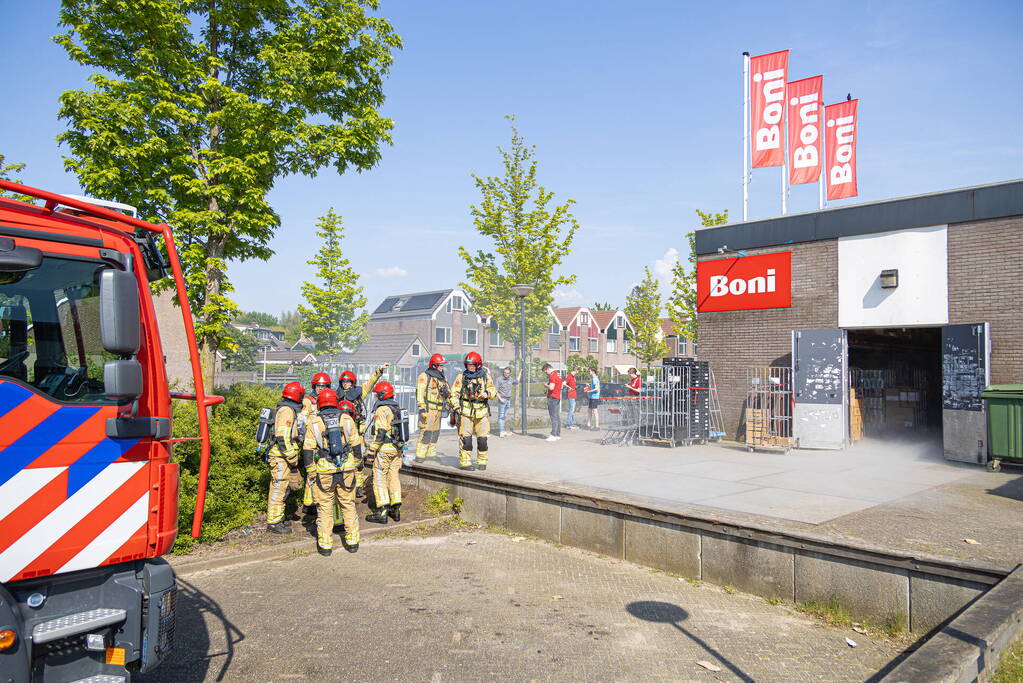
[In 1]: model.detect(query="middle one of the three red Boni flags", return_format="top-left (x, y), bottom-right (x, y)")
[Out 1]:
top-left (787, 76), bottom-right (825, 185)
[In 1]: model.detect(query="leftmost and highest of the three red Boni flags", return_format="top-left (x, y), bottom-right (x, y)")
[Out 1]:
top-left (750, 50), bottom-right (789, 169)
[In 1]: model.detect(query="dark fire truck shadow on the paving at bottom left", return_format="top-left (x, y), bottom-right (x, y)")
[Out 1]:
top-left (138, 577), bottom-right (246, 683)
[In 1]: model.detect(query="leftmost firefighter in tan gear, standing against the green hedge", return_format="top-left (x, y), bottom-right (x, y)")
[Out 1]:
top-left (266, 381), bottom-right (306, 534)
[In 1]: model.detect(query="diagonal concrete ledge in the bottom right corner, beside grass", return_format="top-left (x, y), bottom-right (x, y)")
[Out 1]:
top-left (881, 564), bottom-right (1023, 683)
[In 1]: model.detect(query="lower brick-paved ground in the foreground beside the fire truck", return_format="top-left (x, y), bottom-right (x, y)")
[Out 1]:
top-left (140, 532), bottom-right (900, 683)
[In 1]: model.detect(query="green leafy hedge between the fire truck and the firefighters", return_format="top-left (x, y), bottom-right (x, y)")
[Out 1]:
top-left (174, 384), bottom-right (280, 553)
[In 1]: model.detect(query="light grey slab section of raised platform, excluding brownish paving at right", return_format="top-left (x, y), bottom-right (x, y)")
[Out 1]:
top-left (423, 430), bottom-right (983, 525)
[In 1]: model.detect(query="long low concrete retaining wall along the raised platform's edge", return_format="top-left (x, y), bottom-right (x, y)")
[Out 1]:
top-left (401, 464), bottom-right (1012, 635)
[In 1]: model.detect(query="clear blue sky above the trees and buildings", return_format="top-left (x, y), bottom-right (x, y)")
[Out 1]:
top-left (0, 0), bottom-right (1023, 313)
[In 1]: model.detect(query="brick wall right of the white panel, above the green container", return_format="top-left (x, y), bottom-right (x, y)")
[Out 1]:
top-left (948, 216), bottom-right (1023, 384)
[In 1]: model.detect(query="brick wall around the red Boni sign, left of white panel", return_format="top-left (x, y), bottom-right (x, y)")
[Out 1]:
top-left (697, 239), bottom-right (838, 438)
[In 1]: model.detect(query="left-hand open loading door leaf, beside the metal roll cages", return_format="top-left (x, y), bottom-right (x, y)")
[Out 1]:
top-left (792, 329), bottom-right (849, 450)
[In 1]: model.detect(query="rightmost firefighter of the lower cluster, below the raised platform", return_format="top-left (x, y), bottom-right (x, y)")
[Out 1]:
top-left (366, 381), bottom-right (408, 525)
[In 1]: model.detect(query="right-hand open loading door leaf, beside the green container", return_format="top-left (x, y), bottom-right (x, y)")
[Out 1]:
top-left (941, 323), bottom-right (991, 464)
